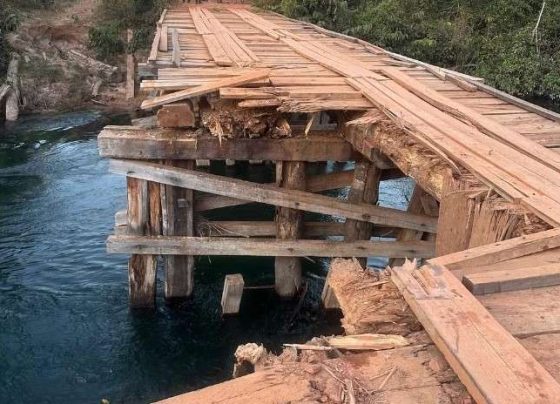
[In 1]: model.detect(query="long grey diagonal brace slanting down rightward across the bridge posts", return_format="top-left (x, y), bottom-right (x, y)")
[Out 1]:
top-left (110, 160), bottom-right (437, 233)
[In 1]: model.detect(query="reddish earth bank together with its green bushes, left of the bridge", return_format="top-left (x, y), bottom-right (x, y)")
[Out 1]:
top-left (0, 0), bottom-right (167, 113)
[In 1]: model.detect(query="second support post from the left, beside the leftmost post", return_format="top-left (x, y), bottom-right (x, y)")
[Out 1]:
top-left (161, 160), bottom-right (195, 300)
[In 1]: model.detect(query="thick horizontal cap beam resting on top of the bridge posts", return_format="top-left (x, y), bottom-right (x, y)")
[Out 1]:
top-left (97, 126), bottom-right (357, 161)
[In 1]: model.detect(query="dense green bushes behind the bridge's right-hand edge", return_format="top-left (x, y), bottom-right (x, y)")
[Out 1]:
top-left (255, 0), bottom-right (560, 100)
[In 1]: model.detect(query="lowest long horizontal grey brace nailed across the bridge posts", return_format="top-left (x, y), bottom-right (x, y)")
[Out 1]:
top-left (107, 235), bottom-right (434, 258)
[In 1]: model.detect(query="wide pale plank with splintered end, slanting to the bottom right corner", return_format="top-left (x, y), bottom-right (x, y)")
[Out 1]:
top-left (391, 263), bottom-right (560, 403)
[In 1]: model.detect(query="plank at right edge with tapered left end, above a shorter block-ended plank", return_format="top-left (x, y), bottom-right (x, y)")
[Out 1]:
top-left (430, 228), bottom-right (560, 270)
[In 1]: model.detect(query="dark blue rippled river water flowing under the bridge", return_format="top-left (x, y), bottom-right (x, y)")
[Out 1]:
top-left (0, 111), bottom-right (410, 403)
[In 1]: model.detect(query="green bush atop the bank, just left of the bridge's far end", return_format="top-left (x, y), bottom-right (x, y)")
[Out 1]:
top-left (89, 0), bottom-right (168, 60)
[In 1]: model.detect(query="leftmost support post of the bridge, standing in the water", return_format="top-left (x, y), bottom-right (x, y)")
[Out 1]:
top-left (127, 178), bottom-right (157, 308)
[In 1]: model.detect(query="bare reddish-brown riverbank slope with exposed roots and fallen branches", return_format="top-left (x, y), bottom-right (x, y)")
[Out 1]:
top-left (1, 0), bottom-right (139, 114)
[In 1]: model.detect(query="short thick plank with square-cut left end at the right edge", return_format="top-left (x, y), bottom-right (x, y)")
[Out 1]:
top-left (463, 264), bottom-right (560, 295)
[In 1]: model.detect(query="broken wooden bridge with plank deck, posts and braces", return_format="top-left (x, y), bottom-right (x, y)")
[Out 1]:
top-left (99, 4), bottom-right (560, 403)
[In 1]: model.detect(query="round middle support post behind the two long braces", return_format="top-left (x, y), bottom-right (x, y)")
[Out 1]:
top-left (274, 161), bottom-right (306, 297)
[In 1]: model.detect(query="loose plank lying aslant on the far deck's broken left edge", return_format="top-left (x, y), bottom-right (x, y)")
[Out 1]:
top-left (142, 69), bottom-right (270, 109)
